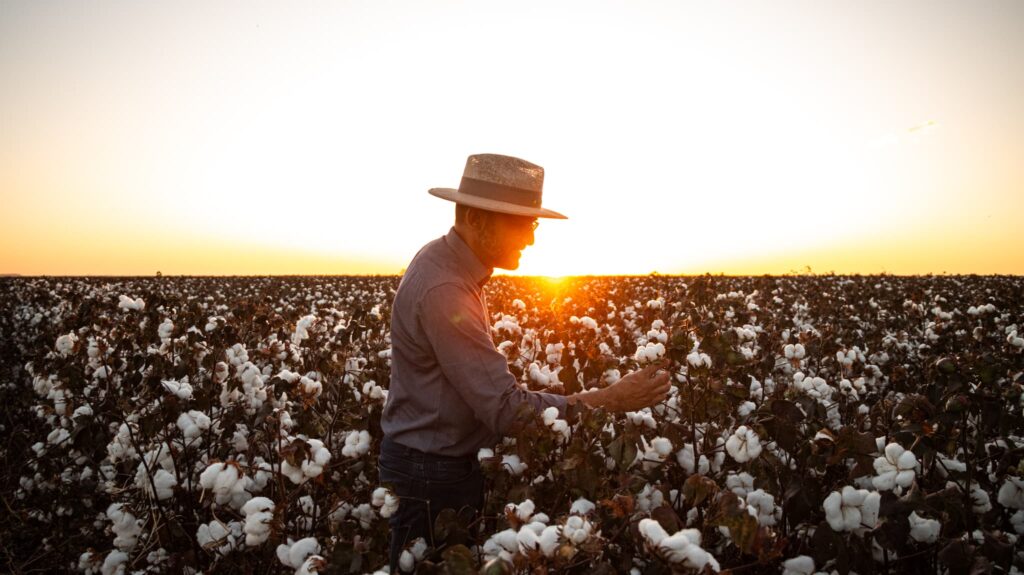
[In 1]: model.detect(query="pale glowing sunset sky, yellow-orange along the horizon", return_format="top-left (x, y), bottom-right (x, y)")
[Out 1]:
top-left (0, 0), bottom-right (1024, 276)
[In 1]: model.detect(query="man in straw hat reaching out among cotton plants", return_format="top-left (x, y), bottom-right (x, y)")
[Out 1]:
top-left (379, 154), bottom-right (669, 573)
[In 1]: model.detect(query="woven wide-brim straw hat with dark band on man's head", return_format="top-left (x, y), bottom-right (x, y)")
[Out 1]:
top-left (429, 153), bottom-right (568, 220)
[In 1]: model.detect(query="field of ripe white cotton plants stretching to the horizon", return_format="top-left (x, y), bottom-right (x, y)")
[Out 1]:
top-left (0, 275), bottom-right (1024, 575)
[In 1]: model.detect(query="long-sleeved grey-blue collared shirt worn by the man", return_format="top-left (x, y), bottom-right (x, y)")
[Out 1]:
top-left (381, 228), bottom-right (566, 456)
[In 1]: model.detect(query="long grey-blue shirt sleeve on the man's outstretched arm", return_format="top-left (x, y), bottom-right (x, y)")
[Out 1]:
top-left (419, 283), bottom-right (566, 435)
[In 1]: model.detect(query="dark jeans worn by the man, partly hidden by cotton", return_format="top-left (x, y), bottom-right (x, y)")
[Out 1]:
top-left (379, 437), bottom-right (483, 573)
